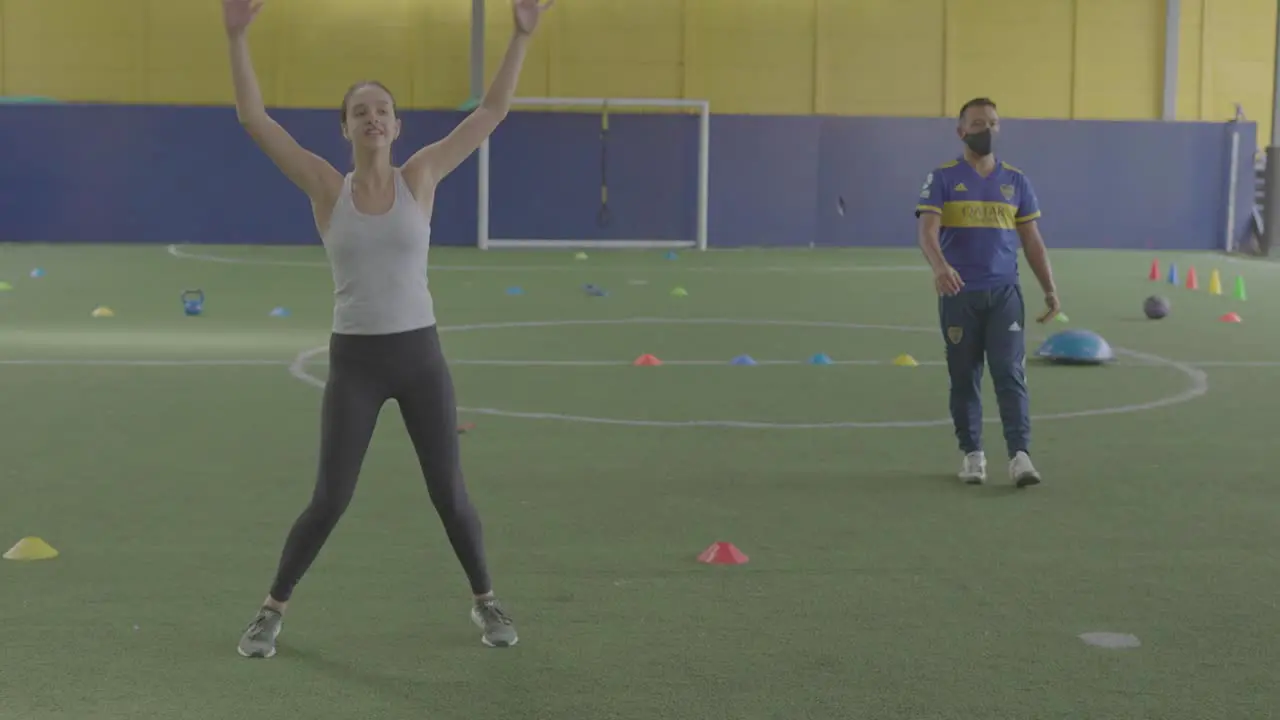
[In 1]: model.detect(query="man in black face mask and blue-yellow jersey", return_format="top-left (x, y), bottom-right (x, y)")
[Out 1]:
top-left (915, 97), bottom-right (1060, 488)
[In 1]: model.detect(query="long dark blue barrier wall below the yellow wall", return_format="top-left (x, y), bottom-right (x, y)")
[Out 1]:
top-left (0, 105), bottom-right (1256, 249)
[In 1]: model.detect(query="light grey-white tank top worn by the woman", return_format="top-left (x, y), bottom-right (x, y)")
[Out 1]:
top-left (323, 168), bottom-right (435, 334)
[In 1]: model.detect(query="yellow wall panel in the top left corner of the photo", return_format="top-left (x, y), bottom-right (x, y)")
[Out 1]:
top-left (4, 0), bottom-right (146, 102)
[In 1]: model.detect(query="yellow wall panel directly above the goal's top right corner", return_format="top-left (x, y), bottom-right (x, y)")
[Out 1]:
top-left (685, 0), bottom-right (817, 114)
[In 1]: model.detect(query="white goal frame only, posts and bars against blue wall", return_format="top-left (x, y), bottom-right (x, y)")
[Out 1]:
top-left (476, 97), bottom-right (712, 250)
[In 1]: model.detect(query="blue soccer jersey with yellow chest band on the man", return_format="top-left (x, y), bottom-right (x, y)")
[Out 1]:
top-left (915, 159), bottom-right (1039, 290)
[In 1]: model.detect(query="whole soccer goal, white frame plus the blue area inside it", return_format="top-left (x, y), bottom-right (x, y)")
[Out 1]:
top-left (476, 97), bottom-right (710, 250)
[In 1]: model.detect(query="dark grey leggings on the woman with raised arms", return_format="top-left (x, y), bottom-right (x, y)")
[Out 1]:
top-left (271, 325), bottom-right (490, 602)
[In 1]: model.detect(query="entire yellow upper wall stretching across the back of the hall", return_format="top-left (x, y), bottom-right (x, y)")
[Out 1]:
top-left (0, 0), bottom-right (1276, 126)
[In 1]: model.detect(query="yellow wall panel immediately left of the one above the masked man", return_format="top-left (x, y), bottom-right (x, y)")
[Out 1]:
top-left (815, 0), bottom-right (948, 117)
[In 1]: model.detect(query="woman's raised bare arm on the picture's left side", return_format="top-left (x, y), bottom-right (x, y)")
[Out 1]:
top-left (223, 0), bottom-right (342, 204)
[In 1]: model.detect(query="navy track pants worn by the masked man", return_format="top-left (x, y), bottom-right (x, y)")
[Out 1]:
top-left (938, 284), bottom-right (1032, 457)
